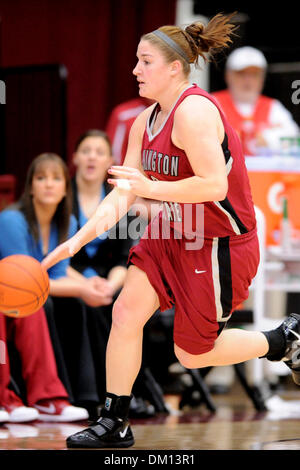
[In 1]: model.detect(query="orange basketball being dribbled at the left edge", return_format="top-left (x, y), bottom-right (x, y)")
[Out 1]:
top-left (0, 255), bottom-right (49, 318)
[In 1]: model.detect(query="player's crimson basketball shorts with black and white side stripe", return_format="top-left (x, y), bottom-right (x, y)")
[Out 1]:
top-left (128, 216), bottom-right (259, 354)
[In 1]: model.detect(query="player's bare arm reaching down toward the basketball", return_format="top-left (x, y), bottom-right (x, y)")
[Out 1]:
top-left (43, 107), bottom-right (152, 269)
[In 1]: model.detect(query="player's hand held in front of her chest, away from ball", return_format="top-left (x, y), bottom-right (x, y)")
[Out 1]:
top-left (107, 165), bottom-right (153, 198)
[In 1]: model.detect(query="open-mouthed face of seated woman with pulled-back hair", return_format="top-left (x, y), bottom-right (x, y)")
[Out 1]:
top-left (73, 137), bottom-right (113, 182)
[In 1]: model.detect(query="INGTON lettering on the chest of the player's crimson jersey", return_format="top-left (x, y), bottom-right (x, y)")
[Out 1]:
top-left (142, 150), bottom-right (179, 176)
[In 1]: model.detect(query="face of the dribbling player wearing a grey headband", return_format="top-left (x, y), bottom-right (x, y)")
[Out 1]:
top-left (132, 40), bottom-right (171, 100)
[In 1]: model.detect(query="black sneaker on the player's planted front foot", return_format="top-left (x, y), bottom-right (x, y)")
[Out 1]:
top-left (66, 417), bottom-right (134, 449)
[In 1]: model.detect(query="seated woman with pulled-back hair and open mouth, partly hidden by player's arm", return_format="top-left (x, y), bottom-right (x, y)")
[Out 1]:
top-left (71, 129), bottom-right (131, 290)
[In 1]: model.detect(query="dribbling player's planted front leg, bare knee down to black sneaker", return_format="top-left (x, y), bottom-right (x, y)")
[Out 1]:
top-left (67, 266), bottom-right (159, 448)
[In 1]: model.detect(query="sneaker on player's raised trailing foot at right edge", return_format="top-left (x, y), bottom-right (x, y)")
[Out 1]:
top-left (281, 313), bottom-right (300, 385)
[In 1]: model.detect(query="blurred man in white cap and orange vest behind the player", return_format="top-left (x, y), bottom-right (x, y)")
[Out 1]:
top-left (213, 46), bottom-right (299, 156)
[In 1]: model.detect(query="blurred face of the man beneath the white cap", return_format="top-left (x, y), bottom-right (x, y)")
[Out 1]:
top-left (226, 67), bottom-right (265, 103)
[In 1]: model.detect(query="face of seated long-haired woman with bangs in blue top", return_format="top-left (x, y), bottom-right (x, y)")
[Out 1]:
top-left (31, 161), bottom-right (66, 207)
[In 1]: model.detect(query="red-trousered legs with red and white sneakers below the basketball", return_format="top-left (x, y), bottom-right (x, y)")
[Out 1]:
top-left (0, 308), bottom-right (88, 423)
